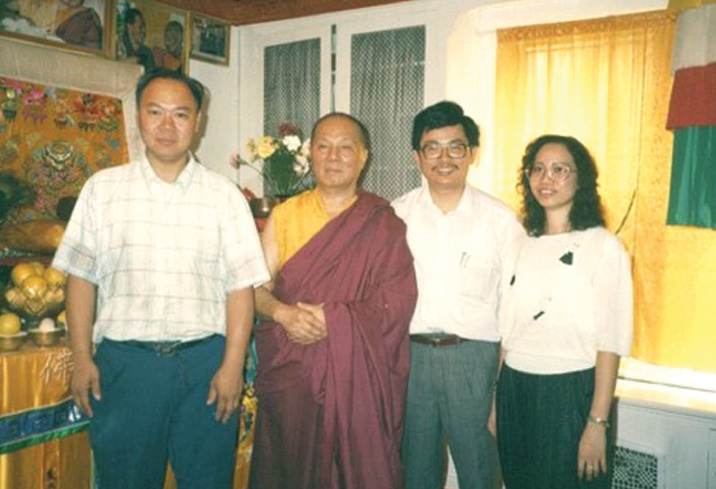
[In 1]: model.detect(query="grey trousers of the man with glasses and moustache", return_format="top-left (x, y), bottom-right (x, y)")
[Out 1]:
top-left (402, 341), bottom-right (499, 489)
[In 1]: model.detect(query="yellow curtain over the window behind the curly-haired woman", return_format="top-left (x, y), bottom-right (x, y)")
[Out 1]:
top-left (493, 12), bottom-right (716, 371)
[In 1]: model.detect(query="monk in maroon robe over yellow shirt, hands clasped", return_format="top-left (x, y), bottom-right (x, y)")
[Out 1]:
top-left (249, 114), bottom-right (417, 489)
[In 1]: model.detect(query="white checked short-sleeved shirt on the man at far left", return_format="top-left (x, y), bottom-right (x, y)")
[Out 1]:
top-left (53, 157), bottom-right (269, 342)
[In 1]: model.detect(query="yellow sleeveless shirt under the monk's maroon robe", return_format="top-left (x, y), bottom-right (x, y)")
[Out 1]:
top-left (271, 189), bottom-right (355, 269)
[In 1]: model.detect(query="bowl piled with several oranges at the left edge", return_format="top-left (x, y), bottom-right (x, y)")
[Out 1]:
top-left (4, 261), bottom-right (67, 329)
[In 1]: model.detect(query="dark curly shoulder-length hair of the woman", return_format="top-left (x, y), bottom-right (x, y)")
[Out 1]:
top-left (517, 134), bottom-right (604, 236)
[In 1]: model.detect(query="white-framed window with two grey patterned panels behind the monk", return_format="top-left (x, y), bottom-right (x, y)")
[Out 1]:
top-left (240, 5), bottom-right (436, 199)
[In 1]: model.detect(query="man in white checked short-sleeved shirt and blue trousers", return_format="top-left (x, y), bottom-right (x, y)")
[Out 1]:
top-left (54, 71), bottom-right (270, 489)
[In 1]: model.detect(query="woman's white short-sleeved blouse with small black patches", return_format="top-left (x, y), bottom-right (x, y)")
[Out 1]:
top-left (500, 227), bottom-right (633, 374)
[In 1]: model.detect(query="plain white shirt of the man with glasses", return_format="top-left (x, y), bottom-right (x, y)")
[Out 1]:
top-left (392, 185), bottom-right (524, 341)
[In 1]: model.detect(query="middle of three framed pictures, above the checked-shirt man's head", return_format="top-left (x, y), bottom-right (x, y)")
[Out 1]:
top-left (114, 0), bottom-right (190, 73)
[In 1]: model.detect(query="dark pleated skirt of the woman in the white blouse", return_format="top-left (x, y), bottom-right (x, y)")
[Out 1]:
top-left (497, 365), bottom-right (613, 489)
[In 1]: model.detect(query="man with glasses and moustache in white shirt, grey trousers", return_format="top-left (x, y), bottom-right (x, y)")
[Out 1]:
top-left (393, 101), bottom-right (524, 489)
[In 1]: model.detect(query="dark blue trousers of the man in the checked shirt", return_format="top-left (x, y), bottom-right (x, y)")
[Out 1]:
top-left (90, 335), bottom-right (238, 489)
